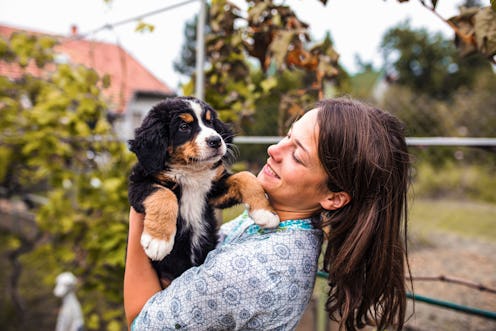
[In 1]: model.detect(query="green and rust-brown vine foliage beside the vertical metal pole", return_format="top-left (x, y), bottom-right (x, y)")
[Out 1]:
top-left (176, 0), bottom-right (341, 132)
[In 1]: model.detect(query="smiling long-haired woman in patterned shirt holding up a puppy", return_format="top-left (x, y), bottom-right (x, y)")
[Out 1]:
top-left (124, 98), bottom-right (409, 330)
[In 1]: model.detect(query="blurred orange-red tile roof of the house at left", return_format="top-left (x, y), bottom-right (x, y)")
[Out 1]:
top-left (0, 25), bottom-right (174, 113)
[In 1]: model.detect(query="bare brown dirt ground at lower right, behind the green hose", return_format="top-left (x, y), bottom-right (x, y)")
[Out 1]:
top-left (407, 233), bottom-right (496, 331)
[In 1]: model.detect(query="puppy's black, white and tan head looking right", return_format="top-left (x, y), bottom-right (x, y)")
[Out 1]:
top-left (129, 97), bottom-right (232, 174)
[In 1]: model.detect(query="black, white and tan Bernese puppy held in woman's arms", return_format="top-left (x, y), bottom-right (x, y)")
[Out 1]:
top-left (128, 97), bottom-right (279, 285)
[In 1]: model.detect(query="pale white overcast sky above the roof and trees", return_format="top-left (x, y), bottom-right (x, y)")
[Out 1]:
top-left (0, 0), bottom-right (490, 94)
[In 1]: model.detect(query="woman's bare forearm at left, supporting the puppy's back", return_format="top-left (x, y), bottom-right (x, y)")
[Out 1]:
top-left (124, 208), bottom-right (161, 326)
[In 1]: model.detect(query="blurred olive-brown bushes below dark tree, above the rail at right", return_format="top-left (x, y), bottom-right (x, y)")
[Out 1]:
top-left (381, 72), bottom-right (496, 137)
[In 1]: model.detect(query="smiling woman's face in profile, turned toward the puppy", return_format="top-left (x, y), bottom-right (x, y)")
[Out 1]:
top-left (258, 109), bottom-right (329, 216)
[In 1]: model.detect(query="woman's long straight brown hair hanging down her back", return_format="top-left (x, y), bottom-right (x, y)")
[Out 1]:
top-left (317, 98), bottom-right (409, 330)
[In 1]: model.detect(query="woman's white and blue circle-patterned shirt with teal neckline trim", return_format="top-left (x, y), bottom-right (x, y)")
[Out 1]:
top-left (132, 212), bottom-right (322, 331)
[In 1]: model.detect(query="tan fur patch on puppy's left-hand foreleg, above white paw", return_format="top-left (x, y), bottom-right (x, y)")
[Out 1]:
top-left (143, 187), bottom-right (179, 241)
